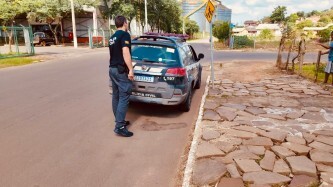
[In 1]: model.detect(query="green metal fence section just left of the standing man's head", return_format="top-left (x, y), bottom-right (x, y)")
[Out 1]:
top-left (88, 27), bottom-right (114, 49)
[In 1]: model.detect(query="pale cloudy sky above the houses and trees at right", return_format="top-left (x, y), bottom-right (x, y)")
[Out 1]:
top-left (222, 0), bottom-right (333, 25)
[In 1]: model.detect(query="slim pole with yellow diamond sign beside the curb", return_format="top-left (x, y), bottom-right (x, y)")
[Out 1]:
top-left (205, 0), bottom-right (215, 89)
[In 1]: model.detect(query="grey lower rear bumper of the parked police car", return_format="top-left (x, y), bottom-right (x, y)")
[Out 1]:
top-left (130, 94), bottom-right (187, 105)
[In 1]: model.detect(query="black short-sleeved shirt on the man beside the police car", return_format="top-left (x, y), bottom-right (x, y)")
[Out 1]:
top-left (109, 30), bottom-right (131, 67)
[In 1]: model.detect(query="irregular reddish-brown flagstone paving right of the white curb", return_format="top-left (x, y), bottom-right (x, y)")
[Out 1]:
top-left (191, 75), bottom-right (333, 187)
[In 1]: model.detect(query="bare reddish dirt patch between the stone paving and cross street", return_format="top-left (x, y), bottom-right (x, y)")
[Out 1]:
top-left (205, 61), bottom-right (282, 82)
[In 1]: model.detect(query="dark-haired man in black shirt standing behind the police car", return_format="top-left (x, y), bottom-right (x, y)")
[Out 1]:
top-left (109, 16), bottom-right (134, 137)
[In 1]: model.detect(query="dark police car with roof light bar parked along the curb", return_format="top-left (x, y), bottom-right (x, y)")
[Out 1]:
top-left (130, 35), bottom-right (204, 112)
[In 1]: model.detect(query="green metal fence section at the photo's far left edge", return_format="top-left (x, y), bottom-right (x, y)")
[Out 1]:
top-left (0, 26), bottom-right (35, 58)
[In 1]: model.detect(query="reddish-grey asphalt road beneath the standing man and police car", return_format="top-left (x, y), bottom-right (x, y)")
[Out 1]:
top-left (0, 47), bottom-right (205, 187)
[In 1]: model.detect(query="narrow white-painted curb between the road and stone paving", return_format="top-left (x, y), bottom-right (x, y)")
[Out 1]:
top-left (182, 76), bottom-right (210, 187)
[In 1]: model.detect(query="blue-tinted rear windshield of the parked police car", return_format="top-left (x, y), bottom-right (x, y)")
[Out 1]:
top-left (132, 44), bottom-right (179, 65)
